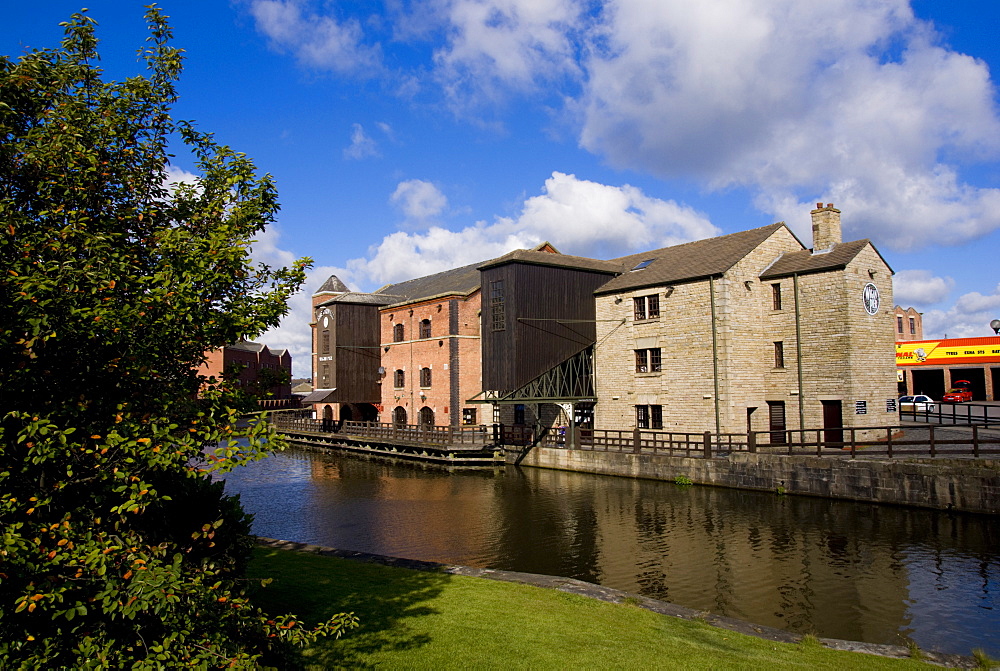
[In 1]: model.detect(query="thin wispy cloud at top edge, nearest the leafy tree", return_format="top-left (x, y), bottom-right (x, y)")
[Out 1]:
top-left (249, 0), bottom-right (381, 76)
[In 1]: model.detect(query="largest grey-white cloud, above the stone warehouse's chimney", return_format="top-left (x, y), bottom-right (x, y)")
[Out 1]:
top-left (580, 0), bottom-right (1000, 250)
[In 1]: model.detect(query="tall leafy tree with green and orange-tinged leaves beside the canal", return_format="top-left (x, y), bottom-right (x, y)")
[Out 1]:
top-left (0, 7), bottom-right (355, 669)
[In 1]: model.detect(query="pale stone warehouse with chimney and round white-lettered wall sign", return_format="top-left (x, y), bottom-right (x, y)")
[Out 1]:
top-left (594, 204), bottom-right (897, 442)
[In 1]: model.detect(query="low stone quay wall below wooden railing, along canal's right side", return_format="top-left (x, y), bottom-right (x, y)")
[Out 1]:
top-left (507, 447), bottom-right (1000, 515)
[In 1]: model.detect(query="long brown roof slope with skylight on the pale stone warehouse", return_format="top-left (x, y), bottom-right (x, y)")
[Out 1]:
top-left (594, 222), bottom-right (786, 296)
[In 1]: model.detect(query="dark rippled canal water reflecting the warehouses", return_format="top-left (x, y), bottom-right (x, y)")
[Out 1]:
top-left (226, 449), bottom-right (1000, 657)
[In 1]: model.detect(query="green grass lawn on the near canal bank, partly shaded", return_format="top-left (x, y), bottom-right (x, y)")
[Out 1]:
top-left (250, 548), bottom-right (940, 669)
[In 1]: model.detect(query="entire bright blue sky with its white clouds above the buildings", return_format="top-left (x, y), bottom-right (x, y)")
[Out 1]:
top-left (7, 0), bottom-right (1000, 375)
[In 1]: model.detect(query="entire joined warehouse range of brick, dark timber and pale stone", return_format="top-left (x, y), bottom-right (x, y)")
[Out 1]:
top-left (313, 204), bottom-right (896, 442)
